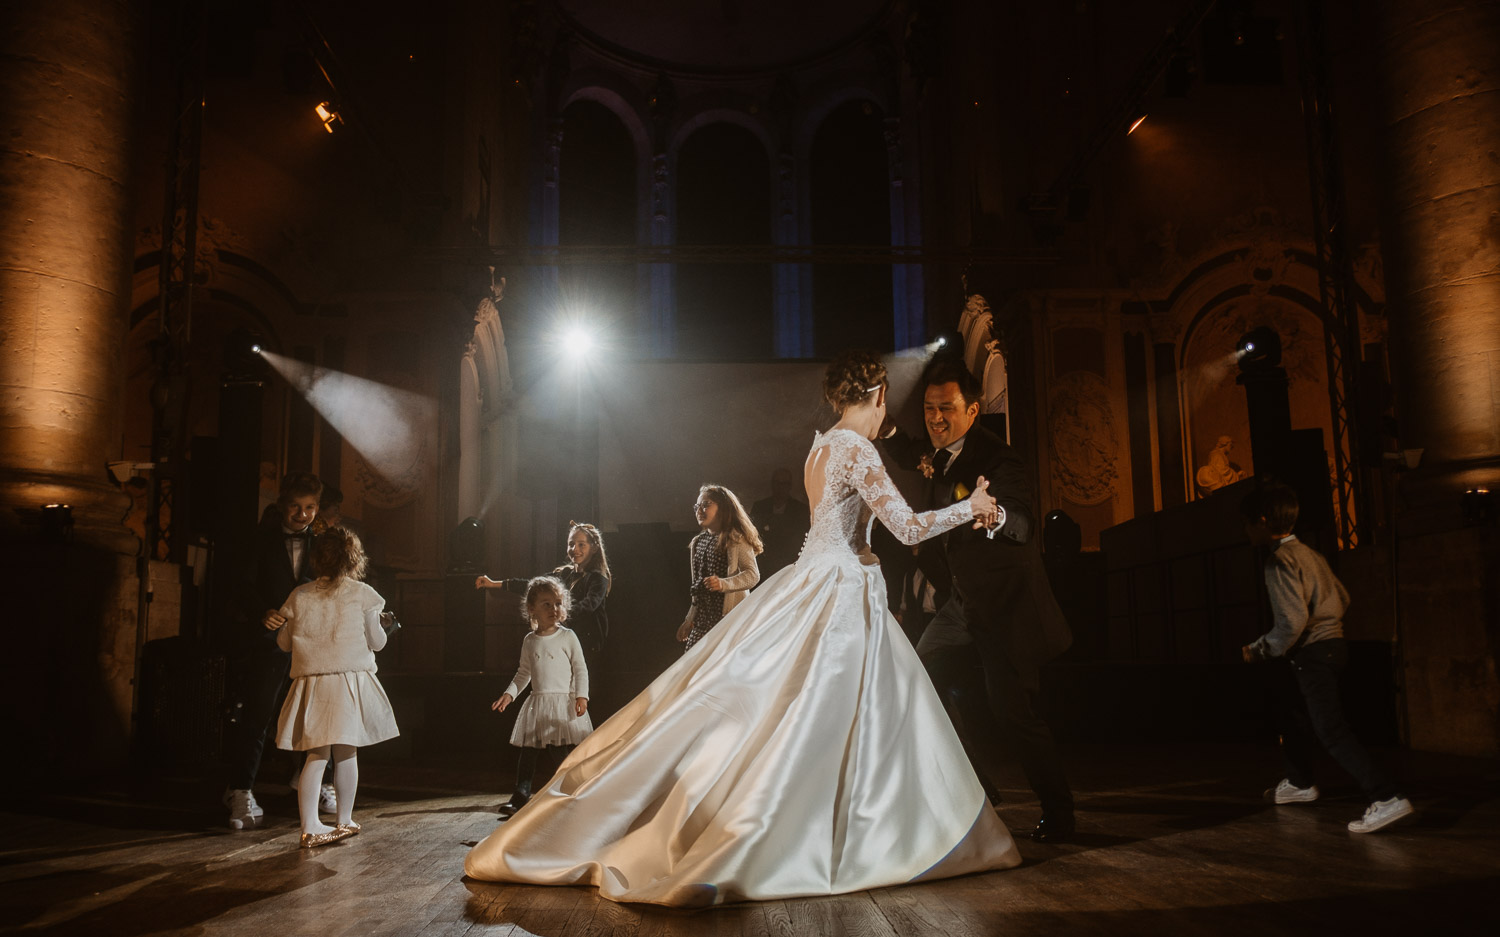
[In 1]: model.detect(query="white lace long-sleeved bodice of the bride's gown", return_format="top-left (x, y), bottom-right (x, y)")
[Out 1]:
top-left (803, 429), bottom-right (974, 559)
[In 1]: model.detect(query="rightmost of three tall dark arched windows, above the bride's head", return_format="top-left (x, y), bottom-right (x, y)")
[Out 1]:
top-left (809, 100), bottom-right (894, 355)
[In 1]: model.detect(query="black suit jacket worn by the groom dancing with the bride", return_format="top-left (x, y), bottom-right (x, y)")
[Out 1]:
top-left (887, 423), bottom-right (1073, 672)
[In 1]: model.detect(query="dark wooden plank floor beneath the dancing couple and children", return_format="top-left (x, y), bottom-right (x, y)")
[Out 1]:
top-left (0, 745), bottom-right (1500, 937)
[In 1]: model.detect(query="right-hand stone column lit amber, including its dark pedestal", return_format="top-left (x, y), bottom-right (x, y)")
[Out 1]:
top-left (1376, 0), bottom-right (1500, 754)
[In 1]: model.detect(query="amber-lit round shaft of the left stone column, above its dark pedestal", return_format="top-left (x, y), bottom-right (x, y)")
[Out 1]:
top-left (0, 0), bottom-right (135, 553)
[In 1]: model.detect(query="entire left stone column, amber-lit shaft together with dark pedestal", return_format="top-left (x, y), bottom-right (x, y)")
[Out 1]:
top-left (0, 0), bottom-right (141, 778)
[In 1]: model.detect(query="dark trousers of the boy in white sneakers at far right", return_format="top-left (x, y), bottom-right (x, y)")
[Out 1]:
top-left (1278, 637), bottom-right (1400, 802)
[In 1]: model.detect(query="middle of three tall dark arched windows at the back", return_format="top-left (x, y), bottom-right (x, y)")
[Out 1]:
top-left (677, 123), bottom-right (771, 358)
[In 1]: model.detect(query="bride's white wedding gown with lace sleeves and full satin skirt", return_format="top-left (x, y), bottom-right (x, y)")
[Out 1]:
top-left (464, 429), bottom-right (1020, 907)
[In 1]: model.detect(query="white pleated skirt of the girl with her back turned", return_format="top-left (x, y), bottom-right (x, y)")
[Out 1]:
top-left (276, 670), bottom-right (401, 751)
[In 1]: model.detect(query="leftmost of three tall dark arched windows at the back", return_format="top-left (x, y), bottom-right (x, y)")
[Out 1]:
top-left (558, 100), bottom-right (638, 330)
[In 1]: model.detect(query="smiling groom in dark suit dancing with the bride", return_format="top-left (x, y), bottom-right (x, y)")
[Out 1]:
top-left (885, 355), bottom-right (1074, 843)
